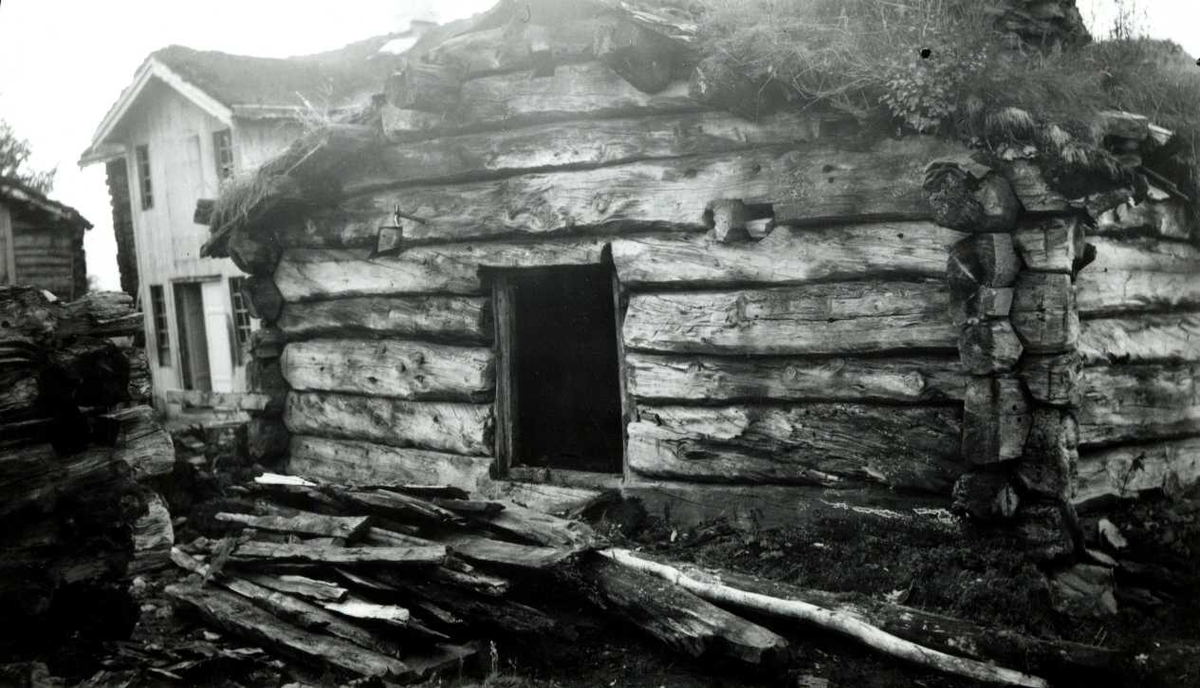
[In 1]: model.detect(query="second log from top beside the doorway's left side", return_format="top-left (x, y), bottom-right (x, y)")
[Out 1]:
top-left (278, 295), bottom-right (492, 343)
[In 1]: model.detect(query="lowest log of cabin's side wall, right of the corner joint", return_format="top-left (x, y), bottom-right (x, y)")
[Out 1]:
top-left (1074, 437), bottom-right (1200, 504)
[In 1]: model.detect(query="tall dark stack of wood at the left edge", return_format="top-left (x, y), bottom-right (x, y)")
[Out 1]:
top-left (0, 287), bottom-right (174, 654)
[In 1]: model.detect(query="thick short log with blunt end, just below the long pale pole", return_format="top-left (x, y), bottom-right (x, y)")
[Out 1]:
top-left (580, 557), bottom-right (787, 666)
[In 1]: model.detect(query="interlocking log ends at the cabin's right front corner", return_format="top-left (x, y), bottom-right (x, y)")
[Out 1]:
top-left (924, 155), bottom-right (1087, 558)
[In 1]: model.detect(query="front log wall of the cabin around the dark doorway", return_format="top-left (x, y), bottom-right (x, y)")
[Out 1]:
top-left (230, 49), bottom-right (984, 525)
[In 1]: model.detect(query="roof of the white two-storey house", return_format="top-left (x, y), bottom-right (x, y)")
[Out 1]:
top-left (79, 22), bottom-right (430, 166)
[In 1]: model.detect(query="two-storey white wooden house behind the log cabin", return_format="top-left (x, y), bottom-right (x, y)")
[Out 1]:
top-left (79, 22), bottom-right (430, 409)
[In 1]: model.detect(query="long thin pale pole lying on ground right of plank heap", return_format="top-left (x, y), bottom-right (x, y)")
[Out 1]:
top-left (614, 554), bottom-right (1123, 682)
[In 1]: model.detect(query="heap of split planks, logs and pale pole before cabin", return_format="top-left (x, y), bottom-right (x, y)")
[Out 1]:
top-left (166, 474), bottom-right (1123, 687)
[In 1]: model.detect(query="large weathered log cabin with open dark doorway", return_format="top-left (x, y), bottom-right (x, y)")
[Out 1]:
top-left (196, 0), bottom-right (1200, 558)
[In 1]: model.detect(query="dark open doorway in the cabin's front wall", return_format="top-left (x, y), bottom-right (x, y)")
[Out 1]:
top-left (497, 265), bottom-right (623, 473)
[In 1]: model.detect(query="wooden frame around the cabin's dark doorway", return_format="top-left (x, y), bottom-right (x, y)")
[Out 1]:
top-left (488, 260), bottom-right (634, 487)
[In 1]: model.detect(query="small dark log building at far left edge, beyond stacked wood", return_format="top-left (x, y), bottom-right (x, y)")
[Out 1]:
top-left (0, 177), bottom-right (91, 300)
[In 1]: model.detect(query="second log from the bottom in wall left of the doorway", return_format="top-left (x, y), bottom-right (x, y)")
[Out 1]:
top-left (283, 391), bottom-right (492, 456)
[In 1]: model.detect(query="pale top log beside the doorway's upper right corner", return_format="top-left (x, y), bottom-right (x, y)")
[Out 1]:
top-left (612, 222), bottom-right (962, 289)
